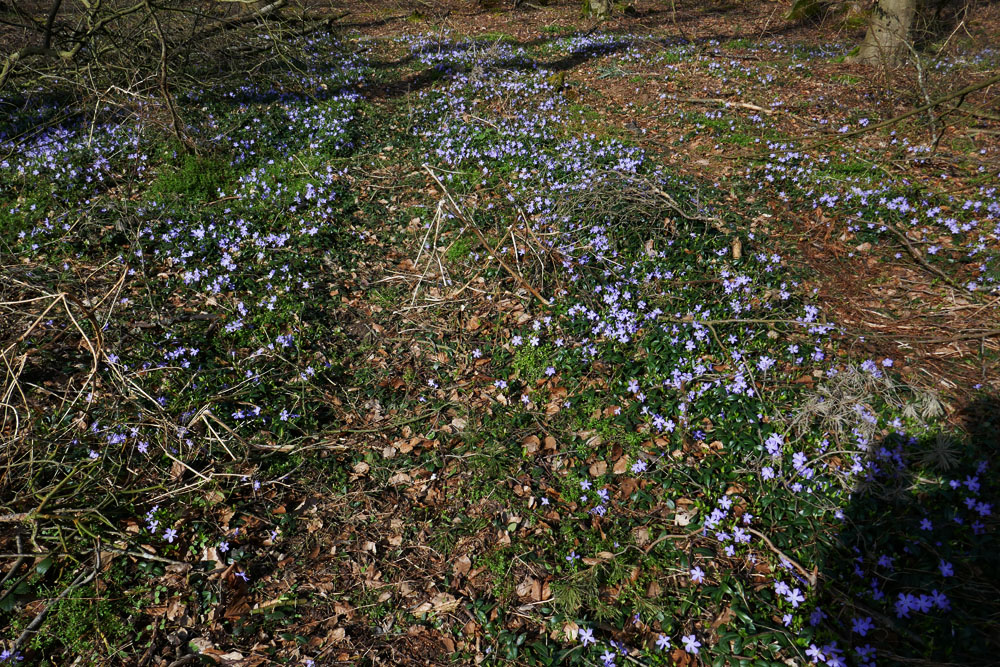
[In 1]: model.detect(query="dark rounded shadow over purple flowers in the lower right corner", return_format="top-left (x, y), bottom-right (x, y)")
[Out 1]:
top-left (812, 396), bottom-right (1000, 665)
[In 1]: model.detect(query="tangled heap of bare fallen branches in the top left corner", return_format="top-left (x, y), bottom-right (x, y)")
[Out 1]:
top-left (0, 0), bottom-right (343, 145)
